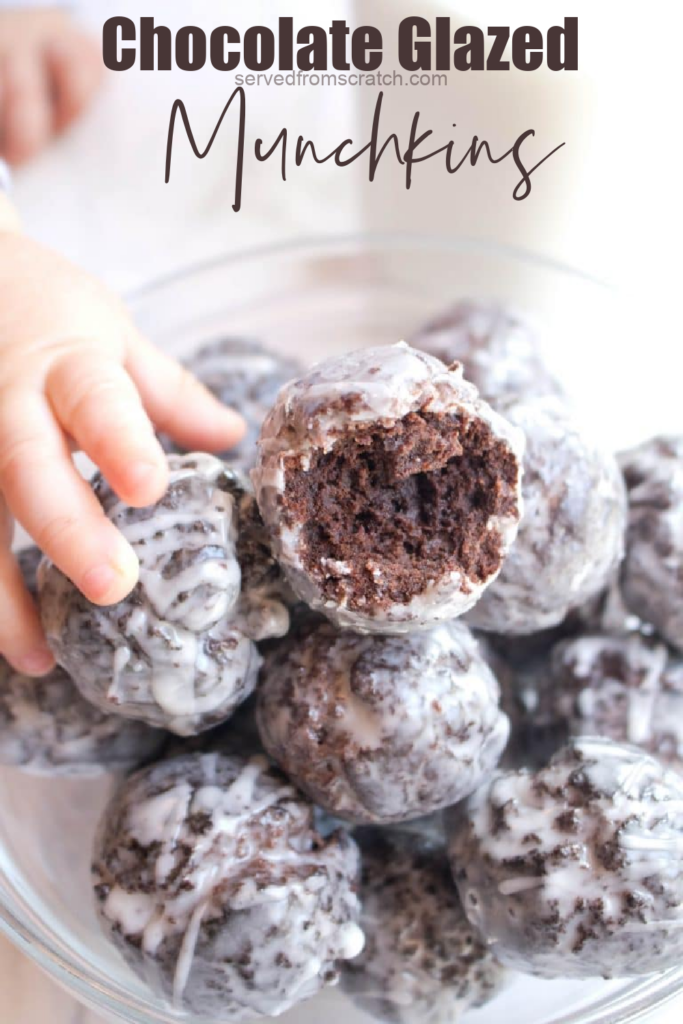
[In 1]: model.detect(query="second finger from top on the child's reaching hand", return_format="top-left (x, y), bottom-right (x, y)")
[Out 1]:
top-left (45, 351), bottom-right (168, 506)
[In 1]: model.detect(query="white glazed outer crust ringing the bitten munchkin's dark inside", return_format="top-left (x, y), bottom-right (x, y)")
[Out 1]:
top-left (252, 342), bottom-right (523, 633)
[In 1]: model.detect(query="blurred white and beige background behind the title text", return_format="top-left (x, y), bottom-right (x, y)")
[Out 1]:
top-left (6, 0), bottom-right (683, 440)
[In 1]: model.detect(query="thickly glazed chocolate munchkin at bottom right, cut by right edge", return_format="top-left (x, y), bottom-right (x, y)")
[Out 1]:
top-left (449, 737), bottom-right (683, 977)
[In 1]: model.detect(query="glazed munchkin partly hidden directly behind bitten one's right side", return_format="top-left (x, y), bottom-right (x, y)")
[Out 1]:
top-left (468, 396), bottom-right (626, 634)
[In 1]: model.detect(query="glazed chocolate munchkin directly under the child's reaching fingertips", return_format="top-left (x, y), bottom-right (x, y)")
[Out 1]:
top-left (41, 455), bottom-right (289, 734)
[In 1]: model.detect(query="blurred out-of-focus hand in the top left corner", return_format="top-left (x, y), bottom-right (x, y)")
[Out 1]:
top-left (0, 7), bottom-right (103, 164)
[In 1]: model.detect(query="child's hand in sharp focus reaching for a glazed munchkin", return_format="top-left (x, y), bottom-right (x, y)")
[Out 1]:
top-left (0, 203), bottom-right (244, 675)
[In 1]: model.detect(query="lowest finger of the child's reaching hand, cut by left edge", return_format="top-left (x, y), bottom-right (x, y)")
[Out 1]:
top-left (0, 495), bottom-right (54, 676)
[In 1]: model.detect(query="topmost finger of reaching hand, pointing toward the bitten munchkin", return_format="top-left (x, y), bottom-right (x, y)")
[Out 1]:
top-left (126, 337), bottom-right (245, 452)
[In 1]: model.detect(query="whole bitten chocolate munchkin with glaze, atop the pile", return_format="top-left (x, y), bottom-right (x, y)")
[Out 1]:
top-left (254, 343), bottom-right (523, 633)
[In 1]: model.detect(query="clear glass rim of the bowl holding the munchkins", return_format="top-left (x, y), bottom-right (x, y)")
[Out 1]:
top-left (0, 231), bottom-right (683, 1024)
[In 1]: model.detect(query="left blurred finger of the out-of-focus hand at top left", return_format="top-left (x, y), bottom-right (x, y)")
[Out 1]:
top-left (2, 50), bottom-right (53, 164)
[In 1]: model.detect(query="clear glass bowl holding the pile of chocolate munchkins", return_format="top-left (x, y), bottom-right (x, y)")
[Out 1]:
top-left (0, 237), bottom-right (683, 1024)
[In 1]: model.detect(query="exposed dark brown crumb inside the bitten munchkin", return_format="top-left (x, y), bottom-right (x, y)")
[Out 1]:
top-left (283, 411), bottom-right (518, 609)
